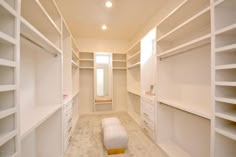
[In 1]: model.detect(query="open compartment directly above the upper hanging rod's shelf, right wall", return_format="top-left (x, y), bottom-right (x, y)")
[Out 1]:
top-left (157, 10), bottom-right (210, 54)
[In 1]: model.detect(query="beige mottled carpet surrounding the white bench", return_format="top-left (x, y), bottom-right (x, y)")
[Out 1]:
top-left (65, 113), bottom-right (165, 157)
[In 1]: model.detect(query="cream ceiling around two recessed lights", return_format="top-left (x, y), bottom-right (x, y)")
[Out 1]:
top-left (56, 0), bottom-right (164, 40)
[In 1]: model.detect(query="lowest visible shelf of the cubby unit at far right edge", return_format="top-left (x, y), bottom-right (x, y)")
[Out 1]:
top-left (215, 126), bottom-right (236, 140)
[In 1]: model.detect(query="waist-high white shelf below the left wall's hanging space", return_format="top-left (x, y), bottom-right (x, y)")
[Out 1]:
top-left (20, 105), bottom-right (61, 139)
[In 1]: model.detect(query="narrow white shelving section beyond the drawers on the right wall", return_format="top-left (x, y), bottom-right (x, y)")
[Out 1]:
top-left (126, 41), bottom-right (141, 125)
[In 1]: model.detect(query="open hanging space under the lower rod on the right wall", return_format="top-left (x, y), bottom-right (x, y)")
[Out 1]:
top-left (157, 104), bottom-right (211, 157)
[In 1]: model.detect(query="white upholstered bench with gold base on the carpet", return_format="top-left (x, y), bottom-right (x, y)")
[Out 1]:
top-left (102, 118), bottom-right (128, 155)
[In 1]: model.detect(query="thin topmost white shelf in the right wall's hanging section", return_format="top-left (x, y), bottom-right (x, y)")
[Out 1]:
top-left (157, 7), bottom-right (210, 43)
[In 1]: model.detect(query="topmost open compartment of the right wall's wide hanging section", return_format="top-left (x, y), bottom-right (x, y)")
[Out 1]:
top-left (157, 0), bottom-right (210, 39)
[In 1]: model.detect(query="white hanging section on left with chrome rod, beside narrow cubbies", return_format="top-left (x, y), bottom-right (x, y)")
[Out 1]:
top-left (19, 0), bottom-right (63, 157)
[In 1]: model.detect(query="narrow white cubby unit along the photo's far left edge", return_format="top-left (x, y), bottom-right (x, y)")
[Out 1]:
top-left (0, 0), bottom-right (20, 157)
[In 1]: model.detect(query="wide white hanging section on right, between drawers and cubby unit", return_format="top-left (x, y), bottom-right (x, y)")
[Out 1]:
top-left (156, 0), bottom-right (212, 157)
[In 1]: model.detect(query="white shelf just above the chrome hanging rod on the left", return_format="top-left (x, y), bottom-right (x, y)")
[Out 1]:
top-left (21, 18), bottom-right (62, 55)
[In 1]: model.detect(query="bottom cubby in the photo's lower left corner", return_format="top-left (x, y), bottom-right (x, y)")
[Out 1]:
top-left (0, 137), bottom-right (16, 157)
